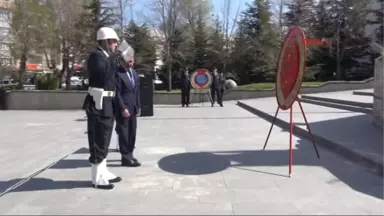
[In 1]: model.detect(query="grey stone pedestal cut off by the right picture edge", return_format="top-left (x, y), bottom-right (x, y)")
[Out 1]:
top-left (373, 56), bottom-right (384, 129)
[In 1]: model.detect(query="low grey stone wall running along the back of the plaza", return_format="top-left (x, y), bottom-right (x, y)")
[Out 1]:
top-left (0, 78), bottom-right (373, 110)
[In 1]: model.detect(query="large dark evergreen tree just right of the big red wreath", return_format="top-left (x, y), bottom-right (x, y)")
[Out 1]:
top-left (310, 0), bottom-right (372, 79)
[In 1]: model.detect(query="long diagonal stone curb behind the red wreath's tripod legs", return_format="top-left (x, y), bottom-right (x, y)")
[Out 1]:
top-left (237, 101), bottom-right (384, 177)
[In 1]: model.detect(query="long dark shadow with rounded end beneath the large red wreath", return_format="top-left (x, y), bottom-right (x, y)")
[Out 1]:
top-left (158, 140), bottom-right (384, 199)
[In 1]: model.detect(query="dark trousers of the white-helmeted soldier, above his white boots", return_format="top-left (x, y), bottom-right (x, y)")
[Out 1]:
top-left (87, 112), bottom-right (114, 164)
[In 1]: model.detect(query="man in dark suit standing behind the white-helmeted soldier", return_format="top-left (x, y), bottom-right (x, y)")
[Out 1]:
top-left (116, 51), bottom-right (141, 167)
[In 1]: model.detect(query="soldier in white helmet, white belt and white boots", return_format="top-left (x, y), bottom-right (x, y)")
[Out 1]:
top-left (83, 27), bottom-right (122, 189)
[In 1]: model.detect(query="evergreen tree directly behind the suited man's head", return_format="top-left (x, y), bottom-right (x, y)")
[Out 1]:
top-left (125, 21), bottom-right (157, 74)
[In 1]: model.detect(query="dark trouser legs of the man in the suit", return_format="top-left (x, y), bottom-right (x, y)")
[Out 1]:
top-left (116, 116), bottom-right (137, 157)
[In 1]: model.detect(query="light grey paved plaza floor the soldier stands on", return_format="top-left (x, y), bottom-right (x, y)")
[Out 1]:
top-left (0, 98), bottom-right (384, 215)
